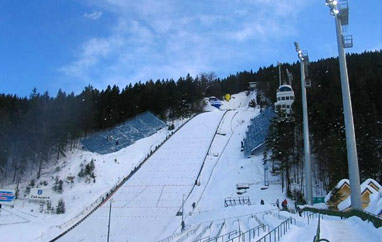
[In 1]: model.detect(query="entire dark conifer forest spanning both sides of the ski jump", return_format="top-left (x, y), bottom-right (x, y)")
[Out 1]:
top-left (0, 51), bottom-right (382, 192)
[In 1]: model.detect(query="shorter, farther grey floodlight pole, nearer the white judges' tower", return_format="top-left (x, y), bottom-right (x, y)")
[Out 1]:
top-left (294, 42), bottom-right (313, 205)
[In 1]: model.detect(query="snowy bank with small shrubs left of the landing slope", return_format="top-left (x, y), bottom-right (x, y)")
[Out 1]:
top-left (0, 120), bottom-right (185, 242)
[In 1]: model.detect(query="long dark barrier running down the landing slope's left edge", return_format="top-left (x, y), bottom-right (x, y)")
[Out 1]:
top-left (50, 115), bottom-right (196, 242)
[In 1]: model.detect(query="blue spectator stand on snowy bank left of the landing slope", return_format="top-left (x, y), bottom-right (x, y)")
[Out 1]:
top-left (81, 112), bottom-right (166, 154)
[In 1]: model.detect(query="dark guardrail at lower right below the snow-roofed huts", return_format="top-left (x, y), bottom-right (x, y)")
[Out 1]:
top-left (303, 207), bottom-right (382, 228)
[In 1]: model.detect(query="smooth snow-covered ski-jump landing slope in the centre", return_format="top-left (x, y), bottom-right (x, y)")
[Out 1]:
top-left (59, 111), bottom-right (223, 242)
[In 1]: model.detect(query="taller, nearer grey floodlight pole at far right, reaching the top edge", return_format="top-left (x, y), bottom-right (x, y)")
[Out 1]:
top-left (326, 0), bottom-right (362, 210)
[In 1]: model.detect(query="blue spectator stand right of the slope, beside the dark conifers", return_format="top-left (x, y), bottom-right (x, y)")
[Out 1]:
top-left (243, 108), bottom-right (276, 157)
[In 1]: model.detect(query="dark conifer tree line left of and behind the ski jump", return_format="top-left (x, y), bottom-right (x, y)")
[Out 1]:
top-left (0, 72), bottom-right (255, 183)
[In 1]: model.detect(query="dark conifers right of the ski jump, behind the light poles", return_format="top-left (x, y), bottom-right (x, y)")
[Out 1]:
top-left (259, 52), bottom-right (382, 195)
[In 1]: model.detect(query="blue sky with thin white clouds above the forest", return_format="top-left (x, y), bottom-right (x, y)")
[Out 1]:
top-left (0, 0), bottom-right (382, 96)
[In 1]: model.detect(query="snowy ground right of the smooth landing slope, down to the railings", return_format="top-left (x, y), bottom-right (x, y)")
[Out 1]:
top-left (157, 93), bottom-right (294, 241)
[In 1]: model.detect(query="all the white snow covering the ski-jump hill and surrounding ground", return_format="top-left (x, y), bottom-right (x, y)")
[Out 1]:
top-left (0, 92), bottom-right (382, 242)
